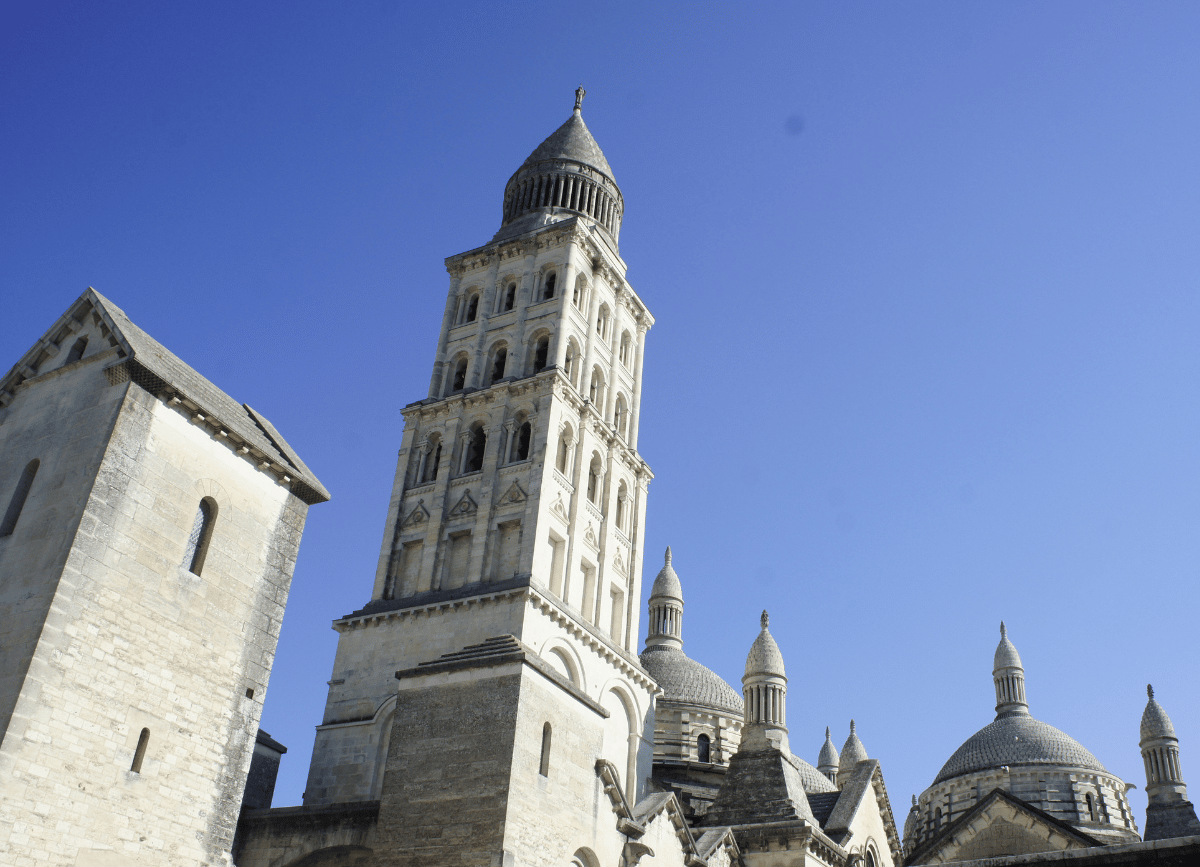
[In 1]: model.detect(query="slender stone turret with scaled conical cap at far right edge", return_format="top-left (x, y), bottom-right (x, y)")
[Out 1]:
top-left (1139, 684), bottom-right (1200, 839)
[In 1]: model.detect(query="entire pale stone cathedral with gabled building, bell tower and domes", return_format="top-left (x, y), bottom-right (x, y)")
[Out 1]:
top-left (0, 89), bottom-right (1200, 867)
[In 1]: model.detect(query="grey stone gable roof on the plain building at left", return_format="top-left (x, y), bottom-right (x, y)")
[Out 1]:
top-left (0, 287), bottom-right (329, 506)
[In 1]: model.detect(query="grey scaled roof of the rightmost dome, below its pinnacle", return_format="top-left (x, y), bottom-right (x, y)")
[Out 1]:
top-left (934, 714), bottom-right (1108, 785)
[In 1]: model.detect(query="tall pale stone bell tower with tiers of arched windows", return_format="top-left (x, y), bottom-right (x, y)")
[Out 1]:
top-left (296, 88), bottom-right (656, 863)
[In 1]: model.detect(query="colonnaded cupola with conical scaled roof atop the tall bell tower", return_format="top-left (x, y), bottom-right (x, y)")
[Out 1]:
top-left (497, 88), bottom-right (625, 244)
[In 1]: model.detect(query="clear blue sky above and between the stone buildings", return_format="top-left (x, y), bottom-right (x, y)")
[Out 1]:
top-left (0, 0), bottom-right (1200, 826)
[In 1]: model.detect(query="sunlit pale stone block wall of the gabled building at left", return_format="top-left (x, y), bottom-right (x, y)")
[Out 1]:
top-left (0, 367), bottom-right (307, 867)
